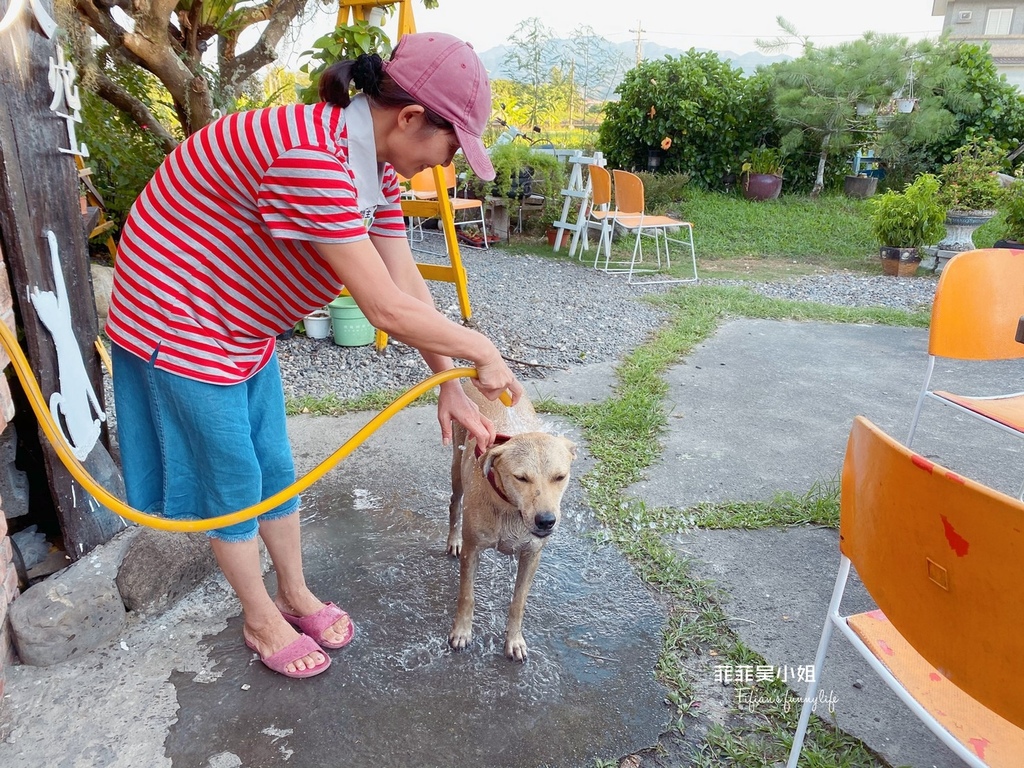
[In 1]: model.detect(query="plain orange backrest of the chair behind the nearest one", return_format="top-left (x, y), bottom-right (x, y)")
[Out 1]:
top-left (928, 248), bottom-right (1024, 360)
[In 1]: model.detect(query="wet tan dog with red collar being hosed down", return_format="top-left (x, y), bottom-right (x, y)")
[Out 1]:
top-left (447, 384), bottom-right (575, 662)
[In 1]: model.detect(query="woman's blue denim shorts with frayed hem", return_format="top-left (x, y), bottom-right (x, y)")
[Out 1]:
top-left (112, 344), bottom-right (299, 542)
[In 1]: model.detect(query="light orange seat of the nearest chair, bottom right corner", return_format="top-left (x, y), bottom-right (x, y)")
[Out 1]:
top-left (846, 610), bottom-right (1024, 768)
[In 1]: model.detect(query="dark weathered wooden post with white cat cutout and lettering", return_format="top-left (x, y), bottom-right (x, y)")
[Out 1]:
top-left (0, 0), bottom-right (125, 559)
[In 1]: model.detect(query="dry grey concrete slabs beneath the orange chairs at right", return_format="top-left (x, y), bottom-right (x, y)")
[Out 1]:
top-left (632, 319), bottom-right (1024, 768)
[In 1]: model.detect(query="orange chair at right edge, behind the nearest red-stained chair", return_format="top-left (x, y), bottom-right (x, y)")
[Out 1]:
top-left (906, 248), bottom-right (1024, 498)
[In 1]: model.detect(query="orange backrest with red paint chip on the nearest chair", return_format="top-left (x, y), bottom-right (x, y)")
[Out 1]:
top-left (840, 416), bottom-right (1024, 727)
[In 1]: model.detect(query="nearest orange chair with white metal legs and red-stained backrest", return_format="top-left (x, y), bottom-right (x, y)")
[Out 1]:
top-left (787, 416), bottom-right (1024, 768)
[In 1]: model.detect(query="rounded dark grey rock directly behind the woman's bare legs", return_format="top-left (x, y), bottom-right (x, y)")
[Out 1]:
top-left (117, 528), bottom-right (217, 613)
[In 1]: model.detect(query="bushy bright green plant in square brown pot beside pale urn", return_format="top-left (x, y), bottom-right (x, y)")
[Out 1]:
top-left (868, 173), bottom-right (946, 276)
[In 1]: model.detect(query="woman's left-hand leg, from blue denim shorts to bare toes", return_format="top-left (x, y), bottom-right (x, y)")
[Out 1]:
top-left (114, 346), bottom-right (326, 672)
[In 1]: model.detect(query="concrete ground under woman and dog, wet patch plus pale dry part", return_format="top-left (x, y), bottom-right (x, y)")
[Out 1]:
top-left (0, 393), bottom-right (672, 768)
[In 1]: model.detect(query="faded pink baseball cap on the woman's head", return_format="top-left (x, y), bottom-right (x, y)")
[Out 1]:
top-left (384, 32), bottom-right (495, 181)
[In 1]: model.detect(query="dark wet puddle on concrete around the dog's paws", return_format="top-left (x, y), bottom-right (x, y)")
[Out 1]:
top-left (166, 475), bottom-right (671, 768)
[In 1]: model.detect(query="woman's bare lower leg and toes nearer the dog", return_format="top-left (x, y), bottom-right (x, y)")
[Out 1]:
top-left (258, 513), bottom-right (349, 643)
